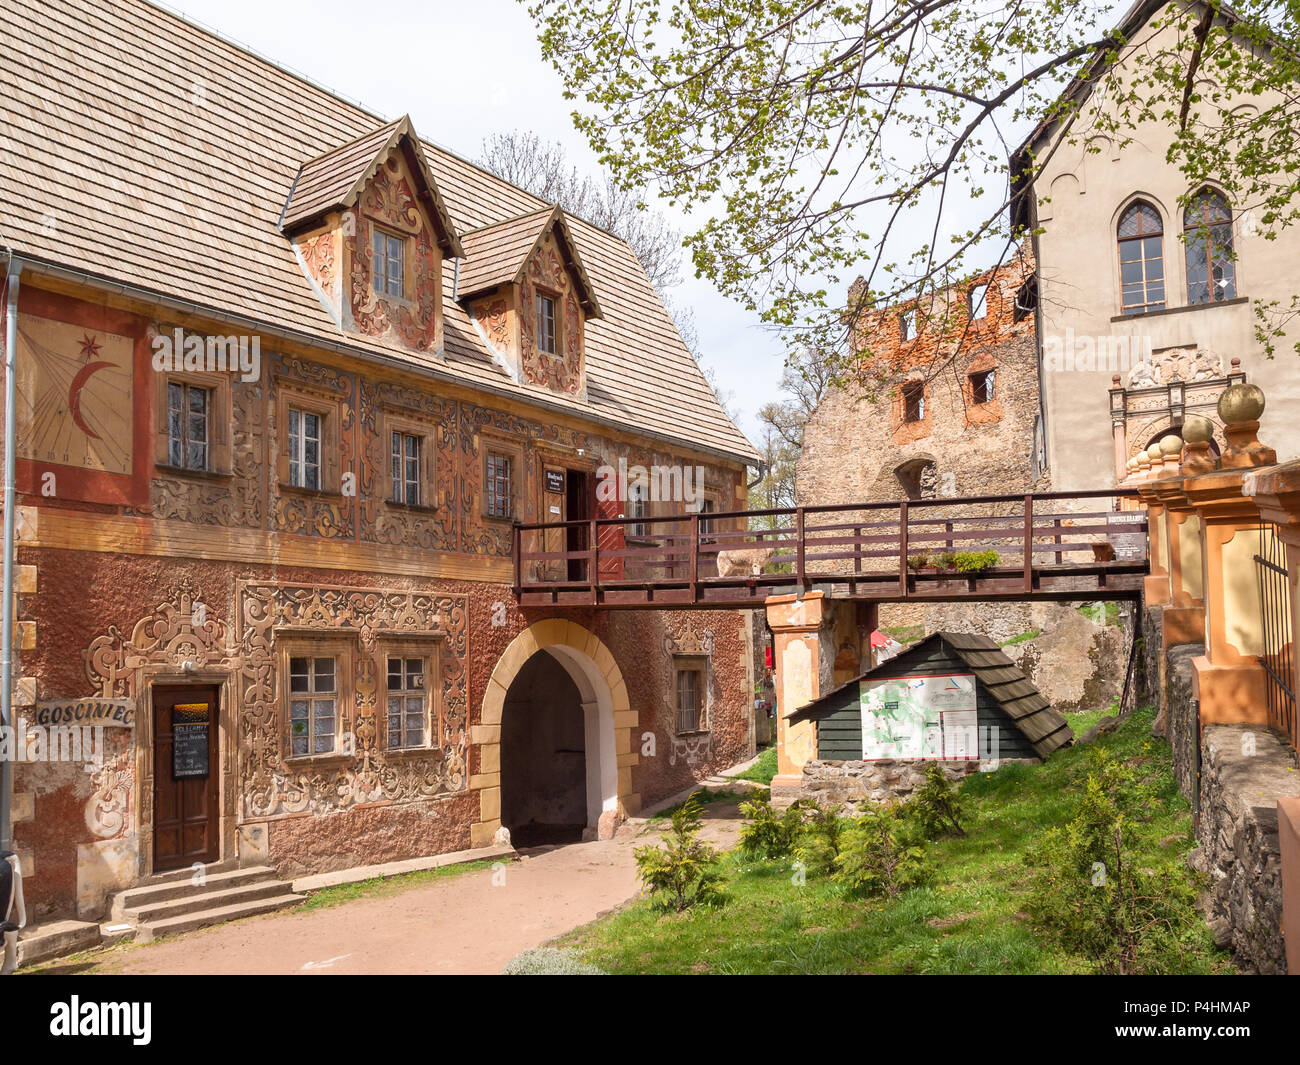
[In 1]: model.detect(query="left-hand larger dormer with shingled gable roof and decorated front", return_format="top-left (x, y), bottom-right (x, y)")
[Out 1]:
top-left (280, 117), bottom-right (464, 352)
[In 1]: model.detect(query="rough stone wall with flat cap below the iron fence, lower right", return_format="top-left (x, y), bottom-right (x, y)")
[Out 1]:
top-left (1190, 724), bottom-right (1300, 975)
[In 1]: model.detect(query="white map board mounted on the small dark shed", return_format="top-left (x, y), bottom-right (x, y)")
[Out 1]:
top-left (861, 674), bottom-right (979, 762)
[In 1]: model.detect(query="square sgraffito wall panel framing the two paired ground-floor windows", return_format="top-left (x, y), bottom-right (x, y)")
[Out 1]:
top-left (239, 581), bottom-right (468, 818)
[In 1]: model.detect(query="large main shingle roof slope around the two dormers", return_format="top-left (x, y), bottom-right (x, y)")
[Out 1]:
top-left (0, 0), bottom-right (759, 463)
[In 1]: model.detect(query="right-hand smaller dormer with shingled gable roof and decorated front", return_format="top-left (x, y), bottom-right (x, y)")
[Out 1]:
top-left (456, 207), bottom-right (601, 395)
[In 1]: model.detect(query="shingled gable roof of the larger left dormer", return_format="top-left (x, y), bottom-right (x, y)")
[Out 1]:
top-left (280, 116), bottom-right (464, 255)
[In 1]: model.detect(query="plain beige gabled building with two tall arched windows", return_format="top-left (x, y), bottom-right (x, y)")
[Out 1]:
top-left (1011, 0), bottom-right (1300, 490)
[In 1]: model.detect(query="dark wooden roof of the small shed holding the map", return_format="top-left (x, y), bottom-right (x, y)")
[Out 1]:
top-left (788, 632), bottom-right (1074, 758)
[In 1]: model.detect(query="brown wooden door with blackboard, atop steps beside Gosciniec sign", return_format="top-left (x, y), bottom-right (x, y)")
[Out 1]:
top-left (153, 687), bottom-right (220, 871)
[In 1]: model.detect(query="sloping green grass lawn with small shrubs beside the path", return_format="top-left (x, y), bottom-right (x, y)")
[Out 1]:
top-left (556, 710), bottom-right (1231, 974)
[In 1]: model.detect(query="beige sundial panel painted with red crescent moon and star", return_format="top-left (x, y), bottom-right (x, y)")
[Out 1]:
top-left (17, 315), bottom-right (134, 475)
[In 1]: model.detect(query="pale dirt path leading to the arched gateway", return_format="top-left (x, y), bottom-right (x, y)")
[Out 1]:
top-left (82, 805), bottom-right (740, 975)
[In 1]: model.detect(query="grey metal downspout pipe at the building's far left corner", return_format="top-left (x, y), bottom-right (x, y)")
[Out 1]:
top-left (0, 252), bottom-right (22, 850)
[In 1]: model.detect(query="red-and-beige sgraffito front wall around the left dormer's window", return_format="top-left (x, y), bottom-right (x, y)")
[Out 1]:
top-left (348, 156), bottom-right (442, 351)
